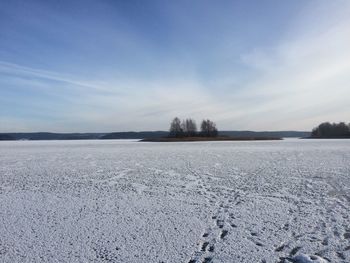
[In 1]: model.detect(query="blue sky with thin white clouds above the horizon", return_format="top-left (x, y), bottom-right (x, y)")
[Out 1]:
top-left (0, 0), bottom-right (350, 132)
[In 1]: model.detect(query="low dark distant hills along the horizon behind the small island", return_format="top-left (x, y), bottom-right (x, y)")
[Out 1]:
top-left (0, 131), bottom-right (310, 140)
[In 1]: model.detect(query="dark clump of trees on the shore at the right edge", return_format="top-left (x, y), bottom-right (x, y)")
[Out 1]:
top-left (311, 122), bottom-right (350, 138)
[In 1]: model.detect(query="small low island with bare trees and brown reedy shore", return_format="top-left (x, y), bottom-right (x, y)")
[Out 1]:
top-left (140, 117), bottom-right (282, 142)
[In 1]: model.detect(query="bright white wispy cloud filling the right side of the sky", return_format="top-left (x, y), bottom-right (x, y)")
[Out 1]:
top-left (227, 1), bottom-right (350, 129)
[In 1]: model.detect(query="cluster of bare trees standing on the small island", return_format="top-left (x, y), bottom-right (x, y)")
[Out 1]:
top-left (169, 117), bottom-right (218, 137)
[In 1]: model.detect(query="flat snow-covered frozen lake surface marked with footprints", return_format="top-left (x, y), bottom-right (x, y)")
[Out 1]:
top-left (0, 139), bottom-right (350, 263)
